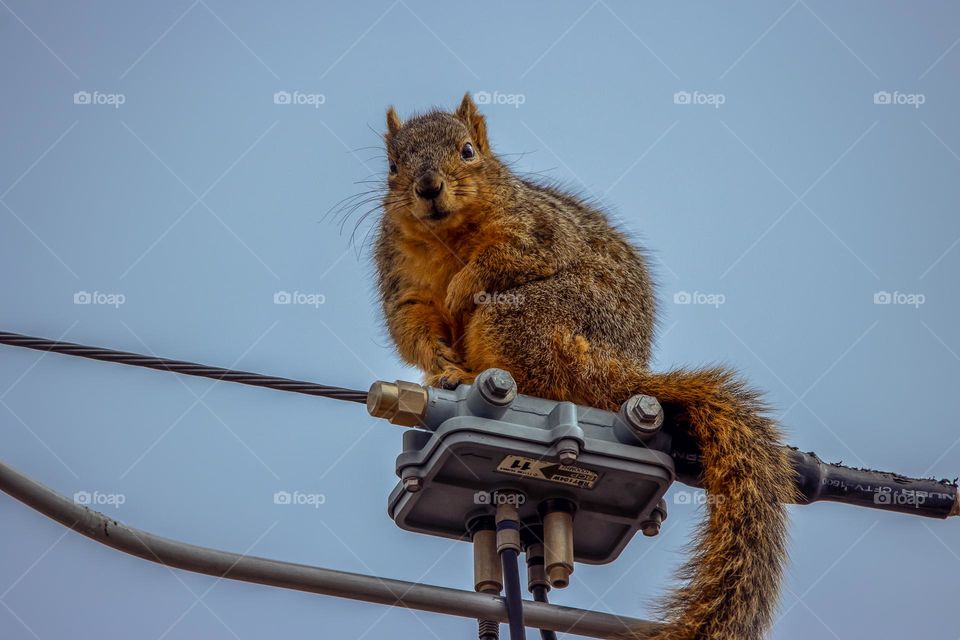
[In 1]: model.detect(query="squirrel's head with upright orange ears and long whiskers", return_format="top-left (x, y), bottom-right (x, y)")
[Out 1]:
top-left (383, 93), bottom-right (501, 231)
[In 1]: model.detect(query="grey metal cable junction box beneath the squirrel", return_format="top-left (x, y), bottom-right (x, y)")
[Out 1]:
top-left (388, 369), bottom-right (675, 564)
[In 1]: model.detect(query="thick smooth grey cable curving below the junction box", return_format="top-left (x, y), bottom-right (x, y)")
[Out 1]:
top-left (0, 462), bottom-right (663, 640)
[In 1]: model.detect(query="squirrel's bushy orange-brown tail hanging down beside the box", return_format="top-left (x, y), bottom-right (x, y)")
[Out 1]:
top-left (612, 368), bottom-right (796, 640)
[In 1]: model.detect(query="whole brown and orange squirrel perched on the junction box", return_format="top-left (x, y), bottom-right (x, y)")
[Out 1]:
top-left (373, 93), bottom-right (795, 640)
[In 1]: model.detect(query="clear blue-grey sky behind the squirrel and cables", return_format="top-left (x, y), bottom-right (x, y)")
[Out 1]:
top-left (0, 0), bottom-right (960, 640)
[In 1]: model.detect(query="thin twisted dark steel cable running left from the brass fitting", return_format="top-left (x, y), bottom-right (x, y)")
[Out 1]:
top-left (0, 331), bottom-right (367, 404)
